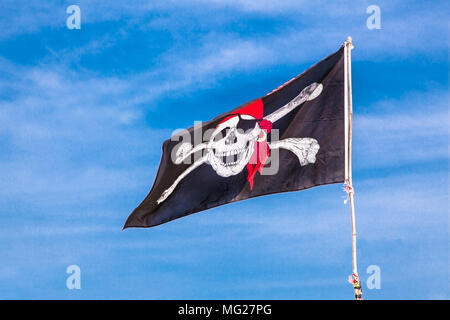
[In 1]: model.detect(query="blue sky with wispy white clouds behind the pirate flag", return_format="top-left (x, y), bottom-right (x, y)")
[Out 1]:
top-left (0, 0), bottom-right (450, 299)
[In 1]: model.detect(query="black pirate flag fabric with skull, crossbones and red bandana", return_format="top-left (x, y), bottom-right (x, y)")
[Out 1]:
top-left (124, 46), bottom-right (345, 228)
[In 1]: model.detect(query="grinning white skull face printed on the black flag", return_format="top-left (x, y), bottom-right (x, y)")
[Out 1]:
top-left (208, 115), bottom-right (261, 177)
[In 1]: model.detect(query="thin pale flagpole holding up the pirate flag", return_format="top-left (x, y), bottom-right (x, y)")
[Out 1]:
top-left (344, 37), bottom-right (362, 300)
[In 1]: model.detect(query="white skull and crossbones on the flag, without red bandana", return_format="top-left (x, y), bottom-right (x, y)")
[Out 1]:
top-left (157, 82), bottom-right (322, 203)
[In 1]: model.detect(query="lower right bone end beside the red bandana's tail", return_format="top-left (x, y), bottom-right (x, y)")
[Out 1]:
top-left (268, 138), bottom-right (320, 166)
